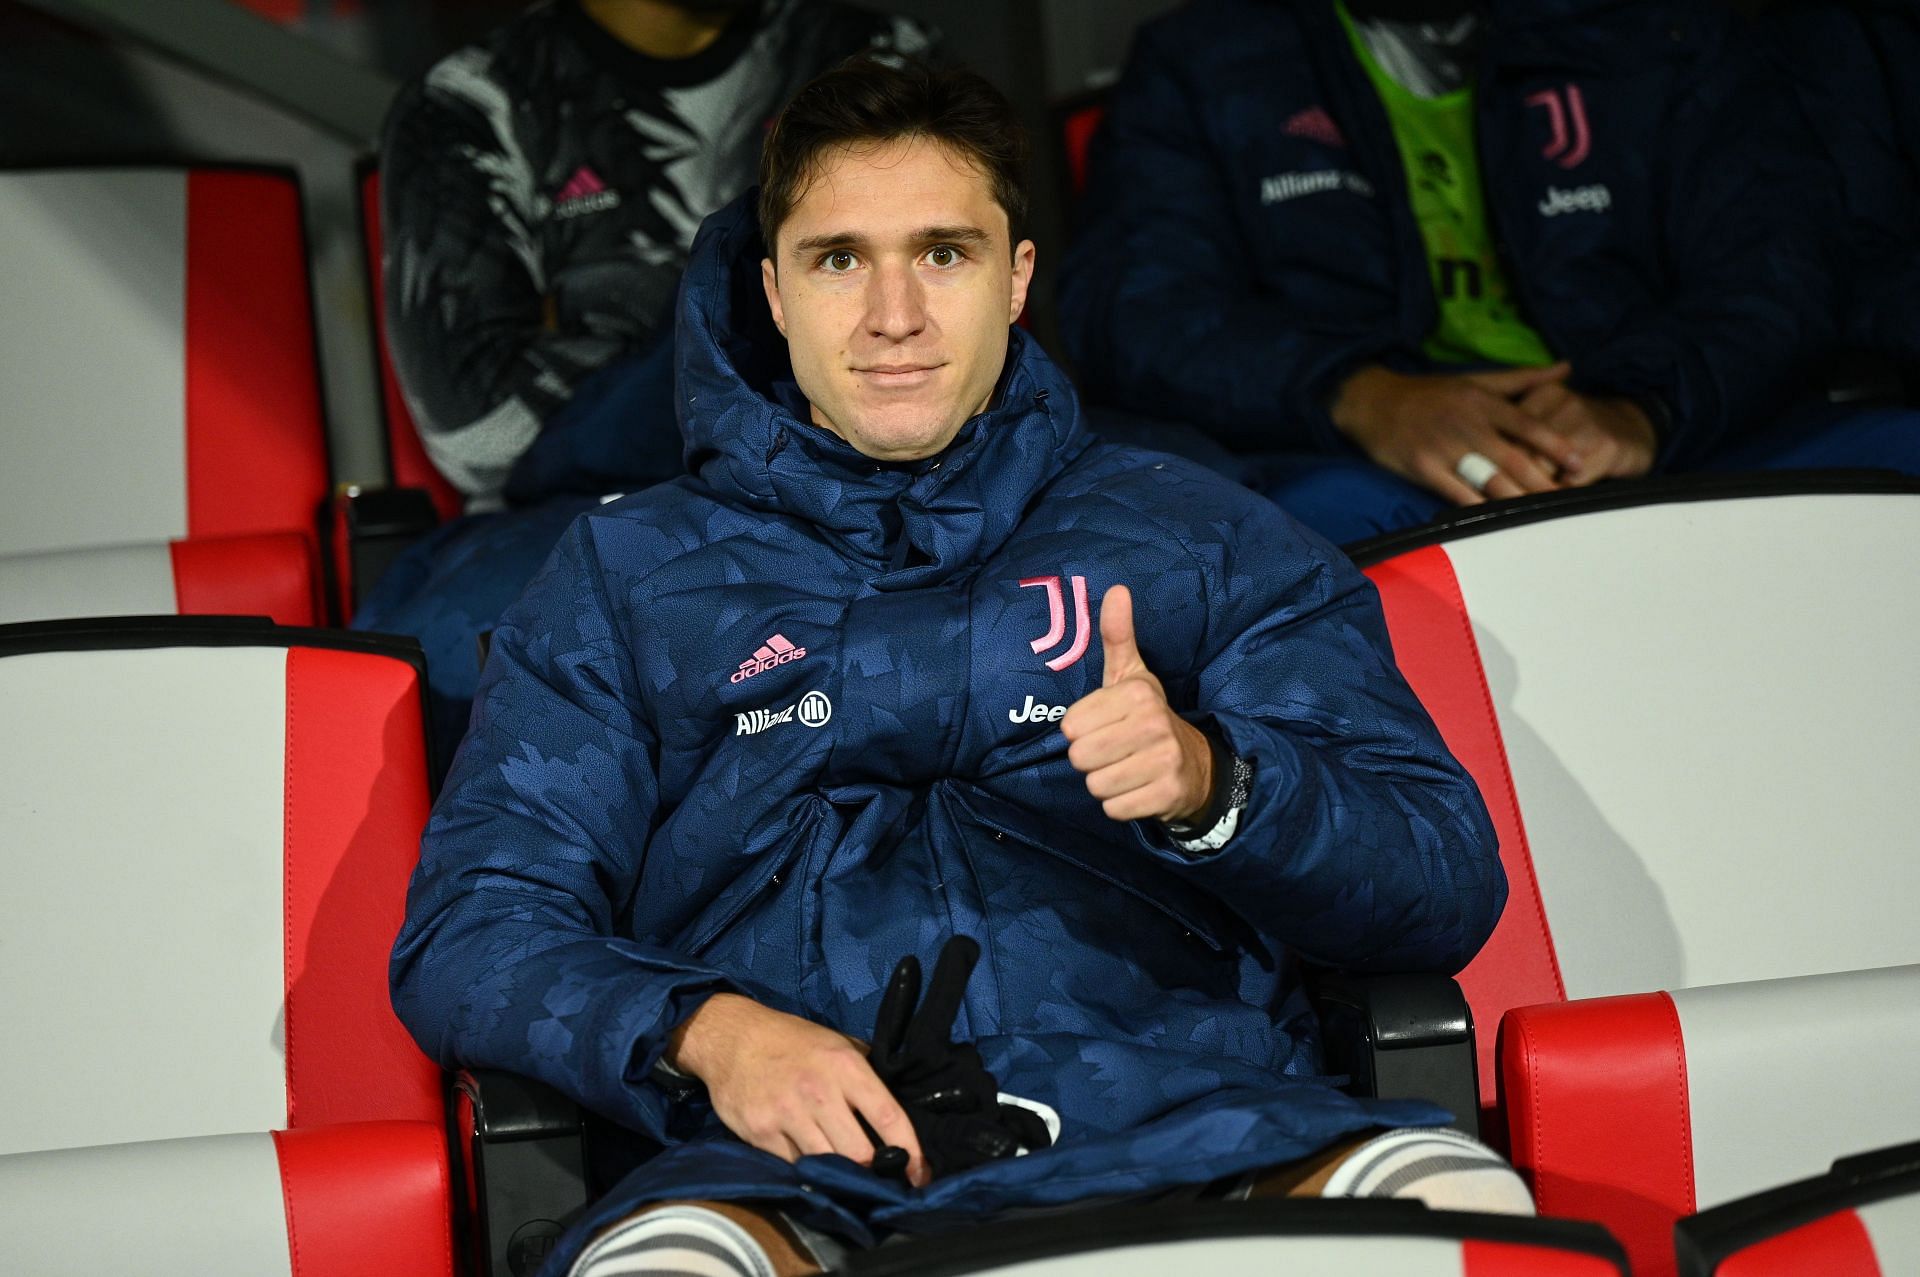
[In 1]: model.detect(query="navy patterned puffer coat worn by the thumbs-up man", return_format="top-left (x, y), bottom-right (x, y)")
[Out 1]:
top-left (394, 193), bottom-right (1505, 1264)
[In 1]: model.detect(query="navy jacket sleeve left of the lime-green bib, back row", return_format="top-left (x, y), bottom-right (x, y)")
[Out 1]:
top-left (1060, 29), bottom-right (1400, 451)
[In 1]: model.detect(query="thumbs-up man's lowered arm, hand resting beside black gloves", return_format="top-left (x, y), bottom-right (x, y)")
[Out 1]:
top-left (392, 520), bottom-right (925, 1183)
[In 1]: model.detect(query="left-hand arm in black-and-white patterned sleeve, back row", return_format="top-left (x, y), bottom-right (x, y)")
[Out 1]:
top-left (380, 59), bottom-right (626, 501)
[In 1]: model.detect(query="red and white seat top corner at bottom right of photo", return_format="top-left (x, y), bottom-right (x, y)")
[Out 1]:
top-left (1674, 1144), bottom-right (1920, 1277)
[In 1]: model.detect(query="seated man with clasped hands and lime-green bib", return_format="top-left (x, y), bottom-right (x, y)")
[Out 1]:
top-left (1062, 0), bottom-right (1920, 542)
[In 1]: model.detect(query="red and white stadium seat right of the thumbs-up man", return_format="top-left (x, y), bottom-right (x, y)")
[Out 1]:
top-left (1352, 474), bottom-right (1920, 1273)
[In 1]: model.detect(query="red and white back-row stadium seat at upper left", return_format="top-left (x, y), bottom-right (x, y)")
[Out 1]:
top-left (0, 167), bottom-right (326, 622)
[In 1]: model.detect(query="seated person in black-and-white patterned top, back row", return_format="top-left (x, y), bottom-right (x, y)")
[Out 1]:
top-left (355, 0), bottom-right (927, 757)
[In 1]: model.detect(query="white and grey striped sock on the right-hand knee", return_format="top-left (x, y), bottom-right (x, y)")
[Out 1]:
top-left (1321, 1127), bottom-right (1534, 1216)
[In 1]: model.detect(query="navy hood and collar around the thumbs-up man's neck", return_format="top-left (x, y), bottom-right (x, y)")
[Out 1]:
top-left (676, 190), bottom-right (1089, 590)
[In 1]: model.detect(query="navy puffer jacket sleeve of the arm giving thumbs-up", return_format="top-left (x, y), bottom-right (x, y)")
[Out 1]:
top-left (1135, 499), bottom-right (1507, 974)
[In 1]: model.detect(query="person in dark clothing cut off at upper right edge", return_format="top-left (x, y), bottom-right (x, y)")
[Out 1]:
top-left (1772, 0), bottom-right (1920, 374)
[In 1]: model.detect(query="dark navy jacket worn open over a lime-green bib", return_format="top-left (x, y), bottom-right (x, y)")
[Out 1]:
top-left (1060, 0), bottom-right (1832, 465)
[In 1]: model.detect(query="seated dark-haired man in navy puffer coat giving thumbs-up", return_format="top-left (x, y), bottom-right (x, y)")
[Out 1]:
top-left (394, 60), bottom-right (1530, 1277)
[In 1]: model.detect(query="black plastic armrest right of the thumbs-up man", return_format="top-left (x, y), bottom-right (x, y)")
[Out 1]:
top-left (1308, 970), bottom-right (1480, 1139)
